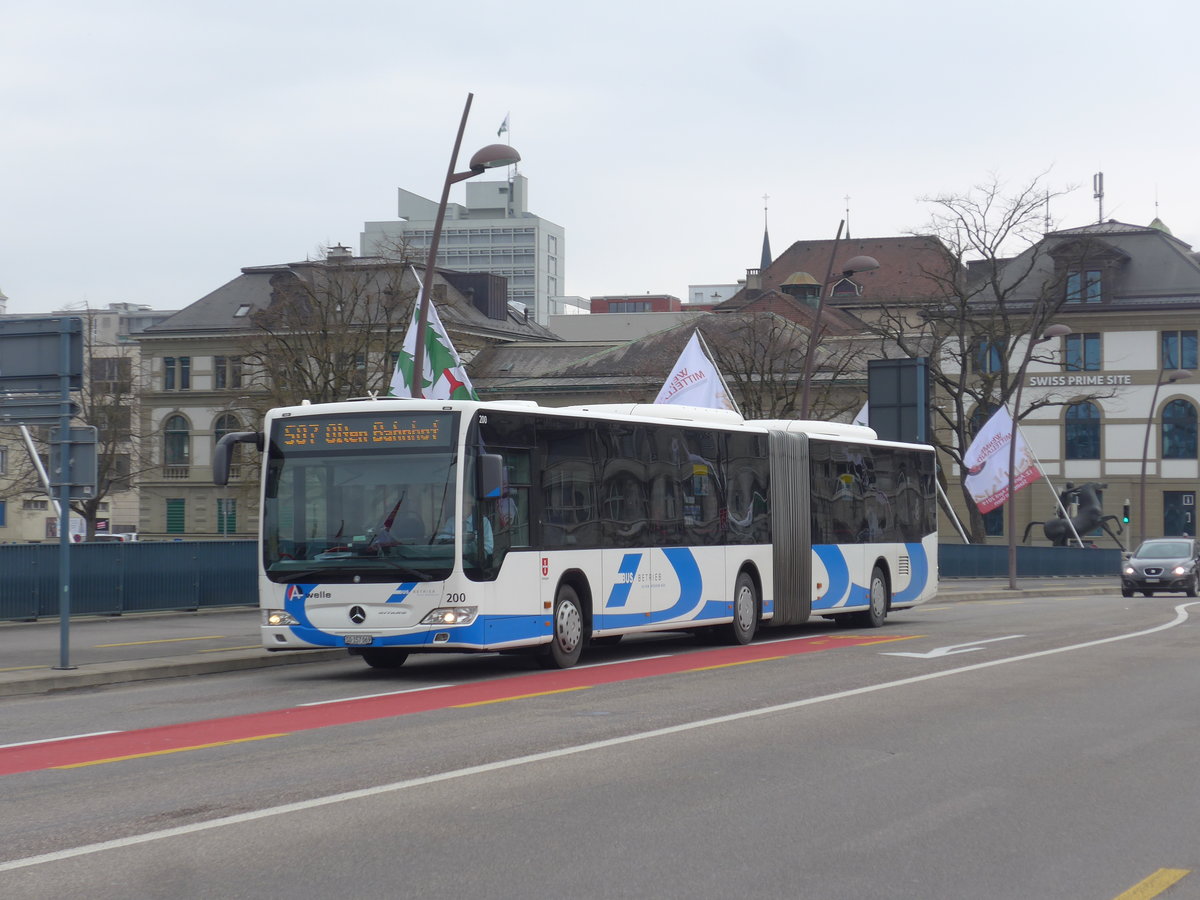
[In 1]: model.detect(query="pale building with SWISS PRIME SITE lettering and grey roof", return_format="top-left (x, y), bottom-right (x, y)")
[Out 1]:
top-left (952, 220), bottom-right (1200, 547)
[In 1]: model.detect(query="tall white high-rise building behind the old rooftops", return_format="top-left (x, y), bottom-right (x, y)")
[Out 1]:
top-left (359, 175), bottom-right (566, 325)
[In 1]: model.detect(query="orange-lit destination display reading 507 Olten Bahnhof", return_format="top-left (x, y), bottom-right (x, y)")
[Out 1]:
top-left (275, 413), bottom-right (454, 450)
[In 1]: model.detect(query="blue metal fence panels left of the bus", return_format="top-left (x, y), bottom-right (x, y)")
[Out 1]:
top-left (0, 540), bottom-right (258, 620)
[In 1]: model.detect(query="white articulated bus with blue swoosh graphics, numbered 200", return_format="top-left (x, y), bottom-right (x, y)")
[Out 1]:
top-left (214, 398), bottom-right (937, 668)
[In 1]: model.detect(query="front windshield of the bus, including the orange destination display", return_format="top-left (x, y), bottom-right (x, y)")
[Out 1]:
top-left (263, 413), bottom-right (458, 583)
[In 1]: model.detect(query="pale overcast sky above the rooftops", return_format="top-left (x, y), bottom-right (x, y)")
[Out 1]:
top-left (0, 0), bottom-right (1200, 313)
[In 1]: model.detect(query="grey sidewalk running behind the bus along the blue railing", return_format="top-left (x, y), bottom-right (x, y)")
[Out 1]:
top-left (0, 576), bottom-right (1121, 697)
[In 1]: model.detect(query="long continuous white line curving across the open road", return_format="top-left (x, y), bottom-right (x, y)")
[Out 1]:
top-left (0, 601), bottom-right (1200, 872)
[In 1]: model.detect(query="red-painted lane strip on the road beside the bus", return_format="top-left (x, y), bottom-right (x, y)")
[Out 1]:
top-left (0, 635), bottom-right (916, 775)
